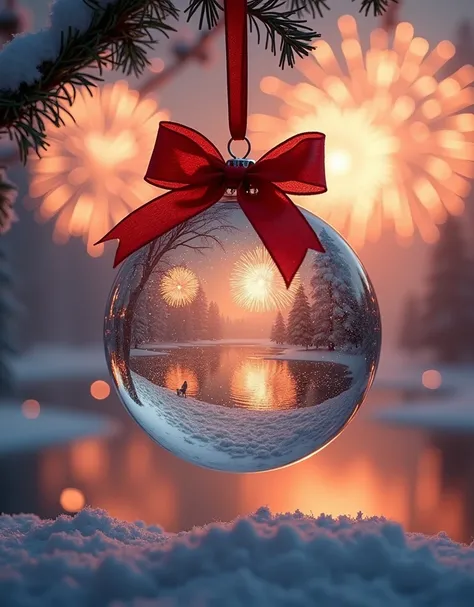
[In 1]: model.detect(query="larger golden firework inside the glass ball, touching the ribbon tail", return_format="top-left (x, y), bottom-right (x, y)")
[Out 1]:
top-left (230, 247), bottom-right (300, 312)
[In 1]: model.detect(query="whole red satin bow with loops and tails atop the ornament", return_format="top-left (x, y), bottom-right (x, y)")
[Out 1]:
top-left (99, 122), bottom-right (327, 286)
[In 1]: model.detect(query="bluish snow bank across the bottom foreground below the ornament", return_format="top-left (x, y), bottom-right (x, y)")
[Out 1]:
top-left (0, 508), bottom-right (474, 607)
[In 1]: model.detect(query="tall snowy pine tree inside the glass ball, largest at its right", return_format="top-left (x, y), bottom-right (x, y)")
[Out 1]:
top-left (311, 230), bottom-right (361, 350)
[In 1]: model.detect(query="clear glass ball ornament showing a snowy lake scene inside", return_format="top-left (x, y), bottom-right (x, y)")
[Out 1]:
top-left (105, 202), bottom-right (381, 472)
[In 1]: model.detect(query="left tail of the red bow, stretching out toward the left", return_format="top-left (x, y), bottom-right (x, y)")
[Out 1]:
top-left (95, 185), bottom-right (224, 268)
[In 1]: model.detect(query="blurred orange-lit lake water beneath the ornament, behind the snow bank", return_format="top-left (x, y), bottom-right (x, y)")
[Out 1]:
top-left (5, 381), bottom-right (474, 542)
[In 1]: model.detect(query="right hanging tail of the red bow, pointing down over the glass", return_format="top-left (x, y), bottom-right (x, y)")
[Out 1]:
top-left (239, 182), bottom-right (324, 288)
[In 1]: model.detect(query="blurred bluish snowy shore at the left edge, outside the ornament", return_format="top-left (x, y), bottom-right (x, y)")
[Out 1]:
top-left (0, 402), bottom-right (118, 456)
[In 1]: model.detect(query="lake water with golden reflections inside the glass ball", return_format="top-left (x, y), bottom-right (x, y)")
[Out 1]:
top-left (131, 346), bottom-right (354, 411)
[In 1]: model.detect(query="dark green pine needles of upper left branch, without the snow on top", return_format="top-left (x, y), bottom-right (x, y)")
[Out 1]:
top-left (0, 0), bottom-right (178, 162)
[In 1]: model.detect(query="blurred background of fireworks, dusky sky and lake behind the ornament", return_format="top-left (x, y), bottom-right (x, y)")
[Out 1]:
top-left (0, 0), bottom-right (474, 541)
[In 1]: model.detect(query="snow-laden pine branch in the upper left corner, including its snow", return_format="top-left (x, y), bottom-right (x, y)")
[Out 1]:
top-left (0, 0), bottom-right (178, 161)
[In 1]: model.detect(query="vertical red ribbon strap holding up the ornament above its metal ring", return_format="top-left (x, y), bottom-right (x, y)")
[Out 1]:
top-left (224, 0), bottom-right (248, 141)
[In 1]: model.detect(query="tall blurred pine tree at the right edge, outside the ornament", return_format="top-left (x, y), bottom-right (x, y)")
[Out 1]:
top-left (420, 217), bottom-right (474, 363)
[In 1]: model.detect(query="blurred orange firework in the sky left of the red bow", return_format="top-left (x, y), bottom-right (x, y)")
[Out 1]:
top-left (30, 81), bottom-right (168, 257)
